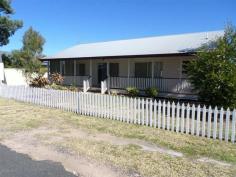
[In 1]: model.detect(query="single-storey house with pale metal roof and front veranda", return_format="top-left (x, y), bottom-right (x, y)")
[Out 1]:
top-left (42, 31), bottom-right (224, 99)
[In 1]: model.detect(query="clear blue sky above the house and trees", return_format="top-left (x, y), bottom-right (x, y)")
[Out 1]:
top-left (0, 0), bottom-right (236, 55)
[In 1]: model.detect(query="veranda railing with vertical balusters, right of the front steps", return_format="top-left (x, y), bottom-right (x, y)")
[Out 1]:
top-left (109, 77), bottom-right (192, 94)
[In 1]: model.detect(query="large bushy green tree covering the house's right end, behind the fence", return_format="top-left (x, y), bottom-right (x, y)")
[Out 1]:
top-left (187, 25), bottom-right (236, 108)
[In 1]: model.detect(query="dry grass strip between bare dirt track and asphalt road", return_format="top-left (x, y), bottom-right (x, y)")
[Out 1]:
top-left (49, 138), bottom-right (236, 177)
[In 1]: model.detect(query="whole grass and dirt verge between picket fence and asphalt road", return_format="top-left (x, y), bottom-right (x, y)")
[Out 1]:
top-left (0, 99), bottom-right (236, 177)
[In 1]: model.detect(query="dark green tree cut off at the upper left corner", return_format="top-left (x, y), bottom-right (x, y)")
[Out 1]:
top-left (0, 0), bottom-right (23, 46)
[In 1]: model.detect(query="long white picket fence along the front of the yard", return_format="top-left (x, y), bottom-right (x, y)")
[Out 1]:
top-left (0, 85), bottom-right (236, 143)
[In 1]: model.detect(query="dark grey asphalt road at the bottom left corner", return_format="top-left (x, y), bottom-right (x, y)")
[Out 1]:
top-left (0, 145), bottom-right (76, 177)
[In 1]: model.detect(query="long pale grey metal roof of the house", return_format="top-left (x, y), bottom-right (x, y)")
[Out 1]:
top-left (44, 30), bottom-right (224, 59)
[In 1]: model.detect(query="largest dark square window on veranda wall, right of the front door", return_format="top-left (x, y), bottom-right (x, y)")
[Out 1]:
top-left (135, 62), bottom-right (152, 77)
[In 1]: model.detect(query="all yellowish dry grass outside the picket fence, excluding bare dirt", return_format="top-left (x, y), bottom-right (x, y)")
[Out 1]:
top-left (0, 99), bottom-right (236, 176)
